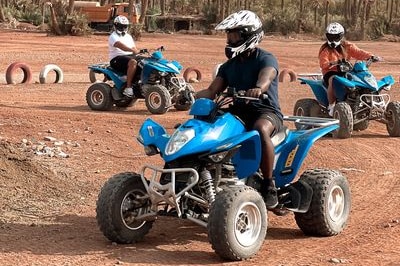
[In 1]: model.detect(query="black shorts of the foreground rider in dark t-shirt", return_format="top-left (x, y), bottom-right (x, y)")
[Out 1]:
top-left (229, 103), bottom-right (283, 137)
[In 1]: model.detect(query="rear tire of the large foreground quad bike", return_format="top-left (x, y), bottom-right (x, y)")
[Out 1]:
top-left (294, 169), bottom-right (351, 236)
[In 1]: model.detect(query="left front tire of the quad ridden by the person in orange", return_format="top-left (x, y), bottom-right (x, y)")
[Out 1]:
top-left (332, 102), bottom-right (353, 139)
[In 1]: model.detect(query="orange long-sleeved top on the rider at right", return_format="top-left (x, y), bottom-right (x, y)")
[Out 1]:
top-left (319, 41), bottom-right (372, 75)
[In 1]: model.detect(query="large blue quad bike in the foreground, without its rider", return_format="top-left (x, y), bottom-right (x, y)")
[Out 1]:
top-left (96, 89), bottom-right (351, 261)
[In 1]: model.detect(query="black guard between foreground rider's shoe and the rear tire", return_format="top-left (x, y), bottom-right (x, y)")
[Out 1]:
top-left (278, 180), bottom-right (313, 213)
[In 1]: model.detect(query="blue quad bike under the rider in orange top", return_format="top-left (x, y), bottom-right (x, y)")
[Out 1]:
top-left (293, 58), bottom-right (400, 138)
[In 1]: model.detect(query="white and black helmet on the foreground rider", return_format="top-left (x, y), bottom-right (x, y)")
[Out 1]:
top-left (215, 10), bottom-right (264, 58)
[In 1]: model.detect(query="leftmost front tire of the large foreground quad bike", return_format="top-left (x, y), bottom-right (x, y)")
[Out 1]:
top-left (96, 173), bottom-right (154, 244)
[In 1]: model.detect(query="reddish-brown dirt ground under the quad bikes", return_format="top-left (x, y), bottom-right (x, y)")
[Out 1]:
top-left (0, 31), bottom-right (400, 266)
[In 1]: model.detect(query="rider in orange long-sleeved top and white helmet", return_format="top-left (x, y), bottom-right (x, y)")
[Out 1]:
top-left (318, 22), bottom-right (380, 116)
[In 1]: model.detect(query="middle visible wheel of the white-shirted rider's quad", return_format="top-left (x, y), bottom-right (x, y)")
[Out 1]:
top-left (145, 85), bottom-right (171, 114)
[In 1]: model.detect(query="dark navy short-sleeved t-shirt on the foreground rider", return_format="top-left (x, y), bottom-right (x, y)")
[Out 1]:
top-left (217, 48), bottom-right (282, 117)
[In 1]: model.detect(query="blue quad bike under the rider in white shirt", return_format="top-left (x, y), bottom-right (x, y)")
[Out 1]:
top-left (86, 46), bottom-right (194, 114)
